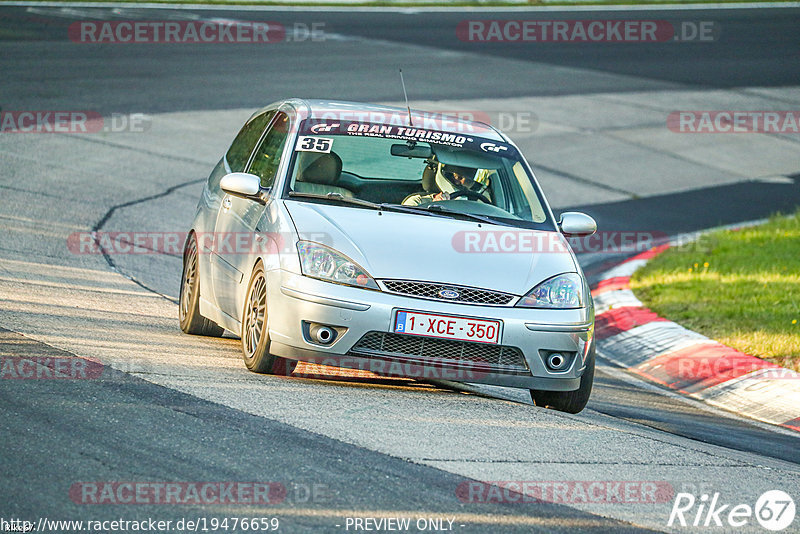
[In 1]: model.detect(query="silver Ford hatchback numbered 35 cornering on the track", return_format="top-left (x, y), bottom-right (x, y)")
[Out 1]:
top-left (179, 99), bottom-right (596, 413)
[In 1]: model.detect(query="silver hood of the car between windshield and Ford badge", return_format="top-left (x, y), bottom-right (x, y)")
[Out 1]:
top-left (285, 201), bottom-right (577, 295)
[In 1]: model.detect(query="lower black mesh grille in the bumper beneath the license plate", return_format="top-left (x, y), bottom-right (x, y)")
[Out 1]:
top-left (350, 332), bottom-right (528, 372)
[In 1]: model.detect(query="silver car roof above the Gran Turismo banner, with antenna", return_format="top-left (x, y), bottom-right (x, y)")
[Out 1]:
top-left (283, 98), bottom-right (506, 141)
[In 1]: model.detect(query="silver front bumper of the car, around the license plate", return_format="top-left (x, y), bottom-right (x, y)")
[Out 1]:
top-left (267, 270), bottom-right (594, 391)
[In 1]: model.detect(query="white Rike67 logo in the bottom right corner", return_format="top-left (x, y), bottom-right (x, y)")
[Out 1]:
top-left (667, 490), bottom-right (795, 532)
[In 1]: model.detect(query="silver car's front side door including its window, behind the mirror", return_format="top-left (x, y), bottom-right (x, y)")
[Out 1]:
top-left (212, 112), bottom-right (289, 320)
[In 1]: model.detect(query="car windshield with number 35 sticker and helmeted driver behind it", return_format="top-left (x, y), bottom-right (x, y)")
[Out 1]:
top-left (287, 120), bottom-right (554, 230)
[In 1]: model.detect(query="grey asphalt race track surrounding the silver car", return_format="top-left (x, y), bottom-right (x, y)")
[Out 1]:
top-left (0, 5), bottom-right (800, 532)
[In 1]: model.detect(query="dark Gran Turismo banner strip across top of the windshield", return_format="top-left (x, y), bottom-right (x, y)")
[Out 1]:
top-left (300, 118), bottom-right (518, 159)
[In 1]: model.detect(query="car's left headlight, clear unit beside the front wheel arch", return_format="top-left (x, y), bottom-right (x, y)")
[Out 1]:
top-left (297, 241), bottom-right (380, 289)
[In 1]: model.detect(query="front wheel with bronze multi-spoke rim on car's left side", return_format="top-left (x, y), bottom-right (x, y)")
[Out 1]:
top-left (241, 263), bottom-right (297, 376)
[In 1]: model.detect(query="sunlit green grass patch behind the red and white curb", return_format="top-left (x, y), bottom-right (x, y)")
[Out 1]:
top-left (631, 210), bottom-right (800, 371)
